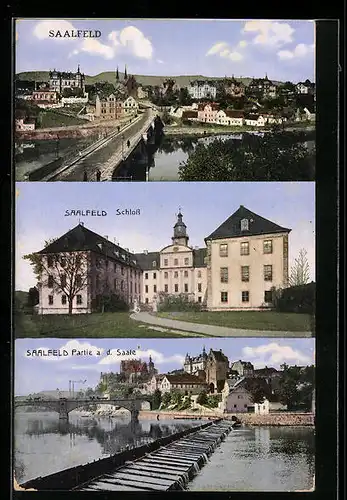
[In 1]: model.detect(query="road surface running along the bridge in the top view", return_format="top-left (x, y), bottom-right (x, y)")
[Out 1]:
top-left (54, 109), bottom-right (154, 181)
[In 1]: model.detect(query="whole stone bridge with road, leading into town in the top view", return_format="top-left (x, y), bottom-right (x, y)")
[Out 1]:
top-left (47, 108), bottom-right (163, 181)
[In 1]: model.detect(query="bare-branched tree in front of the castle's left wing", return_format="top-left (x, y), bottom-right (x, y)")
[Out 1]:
top-left (23, 249), bottom-right (91, 314)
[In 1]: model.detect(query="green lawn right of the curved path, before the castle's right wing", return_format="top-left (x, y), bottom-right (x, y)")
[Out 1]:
top-left (158, 311), bottom-right (312, 332)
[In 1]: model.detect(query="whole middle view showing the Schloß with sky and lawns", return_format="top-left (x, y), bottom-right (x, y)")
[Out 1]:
top-left (15, 182), bottom-right (315, 338)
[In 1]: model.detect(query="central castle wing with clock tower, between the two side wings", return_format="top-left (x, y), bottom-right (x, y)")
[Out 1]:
top-left (135, 212), bottom-right (206, 306)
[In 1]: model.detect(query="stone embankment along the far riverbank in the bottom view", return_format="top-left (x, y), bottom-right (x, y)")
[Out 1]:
top-left (139, 408), bottom-right (314, 427)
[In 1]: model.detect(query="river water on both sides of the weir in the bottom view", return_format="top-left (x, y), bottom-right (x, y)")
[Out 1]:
top-left (14, 412), bottom-right (314, 491)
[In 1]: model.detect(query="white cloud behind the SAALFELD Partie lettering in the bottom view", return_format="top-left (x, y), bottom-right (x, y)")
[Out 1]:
top-left (24, 339), bottom-right (104, 361)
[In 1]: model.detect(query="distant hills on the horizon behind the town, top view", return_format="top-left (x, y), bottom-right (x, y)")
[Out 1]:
top-left (16, 71), bottom-right (281, 87)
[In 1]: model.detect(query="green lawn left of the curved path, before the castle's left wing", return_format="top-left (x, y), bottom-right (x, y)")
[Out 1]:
top-left (15, 312), bottom-right (188, 338)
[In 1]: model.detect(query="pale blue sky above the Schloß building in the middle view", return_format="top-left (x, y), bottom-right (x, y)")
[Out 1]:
top-left (15, 182), bottom-right (315, 290)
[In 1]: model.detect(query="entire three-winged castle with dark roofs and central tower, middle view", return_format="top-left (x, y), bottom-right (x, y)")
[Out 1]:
top-left (32, 205), bottom-right (291, 314)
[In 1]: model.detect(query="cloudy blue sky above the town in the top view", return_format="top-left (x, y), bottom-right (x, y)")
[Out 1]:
top-left (15, 19), bottom-right (315, 82)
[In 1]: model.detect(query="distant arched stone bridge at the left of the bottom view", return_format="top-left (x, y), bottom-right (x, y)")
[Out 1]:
top-left (14, 398), bottom-right (148, 420)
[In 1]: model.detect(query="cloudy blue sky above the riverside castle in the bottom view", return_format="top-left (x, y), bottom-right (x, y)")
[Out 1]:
top-left (14, 338), bottom-right (315, 396)
